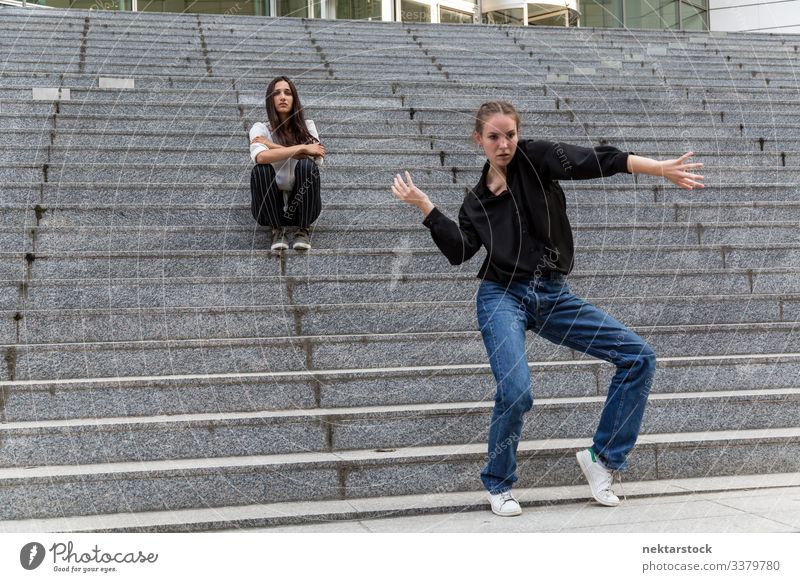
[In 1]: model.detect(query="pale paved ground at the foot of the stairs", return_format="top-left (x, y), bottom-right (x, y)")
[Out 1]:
top-left (250, 487), bottom-right (800, 533)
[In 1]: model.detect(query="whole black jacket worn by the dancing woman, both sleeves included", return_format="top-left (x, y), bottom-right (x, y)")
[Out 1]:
top-left (423, 140), bottom-right (628, 283)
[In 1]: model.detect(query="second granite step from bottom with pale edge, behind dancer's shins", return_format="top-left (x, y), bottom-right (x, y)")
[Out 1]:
top-left (0, 388), bottom-right (800, 468)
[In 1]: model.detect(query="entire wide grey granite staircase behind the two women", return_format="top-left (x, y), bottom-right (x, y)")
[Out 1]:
top-left (0, 6), bottom-right (800, 531)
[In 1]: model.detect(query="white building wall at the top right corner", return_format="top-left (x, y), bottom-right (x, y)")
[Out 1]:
top-left (708, 0), bottom-right (800, 34)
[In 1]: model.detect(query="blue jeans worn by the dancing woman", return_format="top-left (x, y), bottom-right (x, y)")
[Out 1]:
top-left (477, 275), bottom-right (656, 493)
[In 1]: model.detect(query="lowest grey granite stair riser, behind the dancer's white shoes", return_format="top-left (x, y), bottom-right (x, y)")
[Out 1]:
top-left (0, 439), bottom-right (800, 519)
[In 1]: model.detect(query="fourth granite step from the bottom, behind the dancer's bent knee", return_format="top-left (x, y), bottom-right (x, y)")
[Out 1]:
top-left (0, 322), bottom-right (800, 380)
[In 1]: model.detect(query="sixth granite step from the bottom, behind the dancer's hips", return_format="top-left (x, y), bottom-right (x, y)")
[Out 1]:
top-left (0, 268), bottom-right (800, 314)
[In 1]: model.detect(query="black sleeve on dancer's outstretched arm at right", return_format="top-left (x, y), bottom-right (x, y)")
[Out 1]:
top-left (527, 141), bottom-right (629, 180)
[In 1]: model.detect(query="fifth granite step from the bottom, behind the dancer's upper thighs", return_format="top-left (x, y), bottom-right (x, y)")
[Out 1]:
top-left (7, 294), bottom-right (800, 344)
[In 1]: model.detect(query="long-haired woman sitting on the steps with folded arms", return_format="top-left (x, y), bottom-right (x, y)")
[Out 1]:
top-left (250, 77), bottom-right (325, 251)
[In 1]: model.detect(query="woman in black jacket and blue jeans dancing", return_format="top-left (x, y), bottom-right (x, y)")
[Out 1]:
top-left (392, 101), bottom-right (703, 516)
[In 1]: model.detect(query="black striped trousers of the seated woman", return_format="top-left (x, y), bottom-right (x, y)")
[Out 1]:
top-left (250, 160), bottom-right (322, 228)
